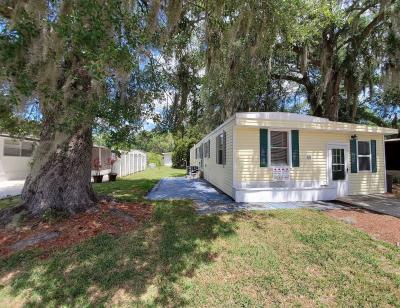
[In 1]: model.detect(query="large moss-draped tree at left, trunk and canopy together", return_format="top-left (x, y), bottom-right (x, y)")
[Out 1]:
top-left (0, 0), bottom-right (162, 215)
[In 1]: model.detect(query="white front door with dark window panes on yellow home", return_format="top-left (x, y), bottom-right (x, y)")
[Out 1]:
top-left (328, 145), bottom-right (349, 197)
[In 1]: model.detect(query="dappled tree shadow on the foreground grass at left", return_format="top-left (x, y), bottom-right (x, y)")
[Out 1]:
top-left (0, 200), bottom-right (236, 306)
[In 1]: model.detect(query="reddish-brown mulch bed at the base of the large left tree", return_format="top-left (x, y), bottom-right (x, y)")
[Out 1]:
top-left (0, 202), bottom-right (153, 257)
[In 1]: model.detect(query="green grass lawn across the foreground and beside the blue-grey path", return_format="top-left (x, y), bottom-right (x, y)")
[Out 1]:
top-left (0, 168), bottom-right (400, 307)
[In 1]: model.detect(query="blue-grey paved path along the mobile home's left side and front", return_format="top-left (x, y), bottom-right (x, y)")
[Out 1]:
top-left (147, 177), bottom-right (342, 214)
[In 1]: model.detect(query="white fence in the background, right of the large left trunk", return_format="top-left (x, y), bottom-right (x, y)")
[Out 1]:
top-left (113, 150), bottom-right (147, 176)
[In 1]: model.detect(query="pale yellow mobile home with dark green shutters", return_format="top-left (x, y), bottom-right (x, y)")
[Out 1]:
top-left (190, 112), bottom-right (397, 202)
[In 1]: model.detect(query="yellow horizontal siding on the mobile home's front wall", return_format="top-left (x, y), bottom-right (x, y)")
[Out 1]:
top-left (236, 125), bottom-right (385, 194)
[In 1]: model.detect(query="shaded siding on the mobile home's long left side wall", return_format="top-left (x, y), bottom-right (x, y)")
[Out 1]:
top-left (190, 121), bottom-right (234, 198)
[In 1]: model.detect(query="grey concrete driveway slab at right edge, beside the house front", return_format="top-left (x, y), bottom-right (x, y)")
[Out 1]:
top-left (337, 194), bottom-right (400, 218)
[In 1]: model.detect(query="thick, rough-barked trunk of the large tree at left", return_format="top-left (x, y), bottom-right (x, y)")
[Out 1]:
top-left (22, 121), bottom-right (95, 216)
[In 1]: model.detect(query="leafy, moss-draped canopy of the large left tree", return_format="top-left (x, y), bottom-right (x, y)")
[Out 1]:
top-left (0, 0), bottom-right (162, 141)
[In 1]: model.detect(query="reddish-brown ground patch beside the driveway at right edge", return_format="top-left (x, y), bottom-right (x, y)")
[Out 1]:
top-left (326, 208), bottom-right (400, 246)
